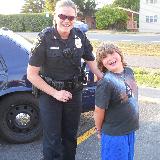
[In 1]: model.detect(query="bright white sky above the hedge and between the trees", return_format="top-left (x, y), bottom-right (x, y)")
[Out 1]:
top-left (0, 0), bottom-right (113, 14)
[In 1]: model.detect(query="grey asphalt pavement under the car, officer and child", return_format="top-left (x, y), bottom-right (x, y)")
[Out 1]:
top-left (0, 102), bottom-right (160, 160)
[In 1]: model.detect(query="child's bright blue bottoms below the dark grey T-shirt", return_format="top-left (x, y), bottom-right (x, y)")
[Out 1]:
top-left (101, 132), bottom-right (135, 160)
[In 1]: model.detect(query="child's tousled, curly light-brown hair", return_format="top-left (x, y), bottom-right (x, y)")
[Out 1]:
top-left (96, 42), bottom-right (127, 72)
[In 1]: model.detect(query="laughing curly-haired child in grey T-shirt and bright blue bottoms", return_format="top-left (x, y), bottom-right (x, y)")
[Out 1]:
top-left (94, 43), bottom-right (139, 160)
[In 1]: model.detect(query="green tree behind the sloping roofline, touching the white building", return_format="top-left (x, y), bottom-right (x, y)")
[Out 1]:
top-left (113, 0), bottom-right (140, 12)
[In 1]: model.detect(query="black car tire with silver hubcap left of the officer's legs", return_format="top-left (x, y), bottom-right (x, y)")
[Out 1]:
top-left (0, 93), bottom-right (42, 143)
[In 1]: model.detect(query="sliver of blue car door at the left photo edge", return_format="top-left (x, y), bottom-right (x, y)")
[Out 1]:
top-left (0, 54), bottom-right (8, 91)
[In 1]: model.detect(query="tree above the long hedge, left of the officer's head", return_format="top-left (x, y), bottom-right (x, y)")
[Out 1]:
top-left (21, 0), bottom-right (45, 13)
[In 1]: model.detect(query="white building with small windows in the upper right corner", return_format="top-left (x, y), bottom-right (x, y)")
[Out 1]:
top-left (139, 0), bottom-right (160, 32)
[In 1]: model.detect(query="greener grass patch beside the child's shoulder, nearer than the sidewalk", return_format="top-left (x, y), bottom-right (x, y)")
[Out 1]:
top-left (132, 67), bottom-right (160, 88)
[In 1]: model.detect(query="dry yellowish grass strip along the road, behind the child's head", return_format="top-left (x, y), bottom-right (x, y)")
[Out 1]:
top-left (91, 41), bottom-right (160, 56)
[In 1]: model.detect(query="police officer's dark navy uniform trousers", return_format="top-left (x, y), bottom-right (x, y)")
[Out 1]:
top-left (39, 92), bottom-right (82, 160)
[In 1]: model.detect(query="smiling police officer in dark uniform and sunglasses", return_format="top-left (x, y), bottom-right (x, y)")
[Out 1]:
top-left (27, 0), bottom-right (103, 160)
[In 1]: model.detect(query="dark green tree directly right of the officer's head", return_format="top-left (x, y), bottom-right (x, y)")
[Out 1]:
top-left (73, 0), bottom-right (96, 17)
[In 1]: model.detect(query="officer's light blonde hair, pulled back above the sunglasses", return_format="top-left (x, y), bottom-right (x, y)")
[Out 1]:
top-left (55, 0), bottom-right (77, 15)
